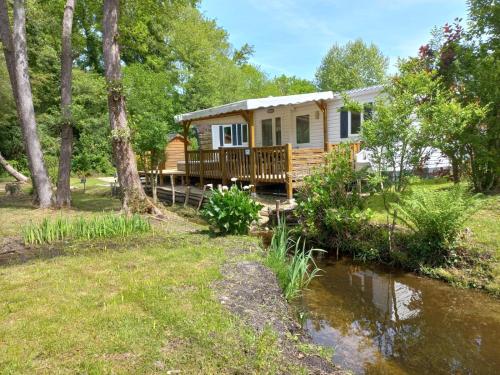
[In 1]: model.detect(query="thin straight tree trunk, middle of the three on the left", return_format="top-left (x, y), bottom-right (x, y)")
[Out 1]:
top-left (56, 0), bottom-right (75, 207)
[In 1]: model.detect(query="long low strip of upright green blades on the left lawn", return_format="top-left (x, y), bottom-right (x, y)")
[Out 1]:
top-left (22, 214), bottom-right (151, 245)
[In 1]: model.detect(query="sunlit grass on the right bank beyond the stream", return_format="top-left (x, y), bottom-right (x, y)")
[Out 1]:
top-left (367, 179), bottom-right (500, 296)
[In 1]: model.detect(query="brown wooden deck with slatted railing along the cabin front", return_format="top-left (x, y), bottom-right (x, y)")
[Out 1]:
top-left (178, 143), bottom-right (360, 199)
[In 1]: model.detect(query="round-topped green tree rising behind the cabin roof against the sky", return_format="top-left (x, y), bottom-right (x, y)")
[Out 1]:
top-left (316, 39), bottom-right (388, 91)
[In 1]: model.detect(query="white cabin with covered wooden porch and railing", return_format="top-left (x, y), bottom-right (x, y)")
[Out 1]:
top-left (176, 86), bottom-right (382, 199)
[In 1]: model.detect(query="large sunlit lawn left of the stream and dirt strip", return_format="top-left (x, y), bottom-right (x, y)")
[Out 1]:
top-left (0, 178), bottom-right (304, 374)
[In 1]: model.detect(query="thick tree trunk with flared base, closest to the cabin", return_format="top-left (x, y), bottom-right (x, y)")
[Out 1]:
top-left (103, 0), bottom-right (159, 214)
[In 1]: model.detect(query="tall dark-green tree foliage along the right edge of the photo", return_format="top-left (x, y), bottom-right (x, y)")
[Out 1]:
top-left (419, 0), bottom-right (500, 192)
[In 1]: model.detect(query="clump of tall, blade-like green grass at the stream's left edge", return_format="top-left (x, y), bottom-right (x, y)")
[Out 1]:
top-left (266, 221), bottom-right (324, 301)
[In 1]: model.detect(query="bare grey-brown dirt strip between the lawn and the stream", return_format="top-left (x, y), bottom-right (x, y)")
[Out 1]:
top-left (213, 251), bottom-right (346, 374)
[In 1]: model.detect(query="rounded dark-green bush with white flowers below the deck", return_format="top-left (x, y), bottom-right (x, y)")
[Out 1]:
top-left (202, 184), bottom-right (264, 234)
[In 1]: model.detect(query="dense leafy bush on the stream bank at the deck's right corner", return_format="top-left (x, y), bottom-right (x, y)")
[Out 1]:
top-left (297, 144), bottom-right (371, 251)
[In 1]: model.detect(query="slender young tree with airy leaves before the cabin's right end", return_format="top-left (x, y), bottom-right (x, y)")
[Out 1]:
top-left (361, 62), bottom-right (432, 253)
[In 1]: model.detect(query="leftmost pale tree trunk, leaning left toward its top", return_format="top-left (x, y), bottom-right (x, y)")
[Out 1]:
top-left (0, 0), bottom-right (52, 208)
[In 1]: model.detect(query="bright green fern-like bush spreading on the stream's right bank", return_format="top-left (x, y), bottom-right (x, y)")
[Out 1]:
top-left (393, 187), bottom-right (479, 265)
